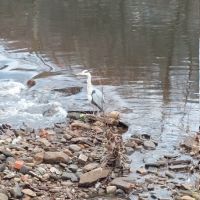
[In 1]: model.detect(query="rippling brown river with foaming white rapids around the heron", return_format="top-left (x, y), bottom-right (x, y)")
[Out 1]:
top-left (0, 0), bottom-right (200, 195)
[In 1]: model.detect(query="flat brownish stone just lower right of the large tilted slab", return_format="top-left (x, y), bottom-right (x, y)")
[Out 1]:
top-left (110, 177), bottom-right (135, 191)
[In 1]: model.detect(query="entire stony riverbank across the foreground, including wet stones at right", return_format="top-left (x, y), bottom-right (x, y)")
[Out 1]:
top-left (0, 112), bottom-right (200, 200)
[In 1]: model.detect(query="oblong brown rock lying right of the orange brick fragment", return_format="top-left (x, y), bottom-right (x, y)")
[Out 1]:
top-left (44, 151), bottom-right (69, 163)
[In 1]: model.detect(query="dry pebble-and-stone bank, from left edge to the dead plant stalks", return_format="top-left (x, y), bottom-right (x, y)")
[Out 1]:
top-left (0, 112), bottom-right (135, 200)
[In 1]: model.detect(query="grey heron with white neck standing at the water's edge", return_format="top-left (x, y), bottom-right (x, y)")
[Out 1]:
top-left (77, 70), bottom-right (105, 111)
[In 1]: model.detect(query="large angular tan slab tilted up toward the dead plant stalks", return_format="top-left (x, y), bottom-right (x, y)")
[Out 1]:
top-left (79, 167), bottom-right (110, 185)
